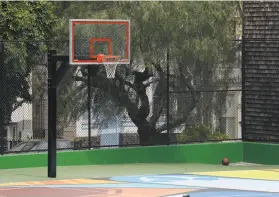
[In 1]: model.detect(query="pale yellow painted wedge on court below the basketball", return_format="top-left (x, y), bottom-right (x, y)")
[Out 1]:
top-left (191, 169), bottom-right (279, 180)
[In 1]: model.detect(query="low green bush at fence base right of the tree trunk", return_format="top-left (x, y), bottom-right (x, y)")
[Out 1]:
top-left (177, 124), bottom-right (229, 142)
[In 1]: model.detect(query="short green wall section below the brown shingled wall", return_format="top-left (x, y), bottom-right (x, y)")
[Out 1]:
top-left (243, 142), bottom-right (279, 165)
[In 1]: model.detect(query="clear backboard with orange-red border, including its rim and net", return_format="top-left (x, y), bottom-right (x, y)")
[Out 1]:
top-left (69, 19), bottom-right (131, 78)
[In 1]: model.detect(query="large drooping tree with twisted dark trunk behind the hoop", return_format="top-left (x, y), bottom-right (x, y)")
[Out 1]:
top-left (54, 2), bottom-right (241, 145)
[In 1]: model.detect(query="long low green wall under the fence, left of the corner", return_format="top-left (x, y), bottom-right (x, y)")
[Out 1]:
top-left (0, 142), bottom-right (243, 169)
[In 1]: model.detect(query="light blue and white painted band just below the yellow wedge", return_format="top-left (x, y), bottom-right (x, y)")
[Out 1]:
top-left (111, 174), bottom-right (279, 193)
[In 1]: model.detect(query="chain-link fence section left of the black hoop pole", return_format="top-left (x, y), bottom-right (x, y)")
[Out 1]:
top-left (0, 41), bottom-right (47, 154)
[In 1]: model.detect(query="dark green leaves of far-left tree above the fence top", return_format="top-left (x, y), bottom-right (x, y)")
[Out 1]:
top-left (0, 1), bottom-right (57, 41)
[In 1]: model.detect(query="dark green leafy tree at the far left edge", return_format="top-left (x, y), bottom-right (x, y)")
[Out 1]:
top-left (0, 1), bottom-right (56, 145)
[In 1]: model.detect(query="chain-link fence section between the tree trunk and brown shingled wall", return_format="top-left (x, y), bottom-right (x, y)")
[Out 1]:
top-left (168, 41), bottom-right (242, 143)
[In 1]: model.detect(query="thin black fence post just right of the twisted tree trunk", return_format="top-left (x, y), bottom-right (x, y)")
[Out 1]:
top-left (166, 48), bottom-right (170, 145)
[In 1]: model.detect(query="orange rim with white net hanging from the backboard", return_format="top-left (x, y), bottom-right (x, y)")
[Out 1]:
top-left (97, 54), bottom-right (121, 79)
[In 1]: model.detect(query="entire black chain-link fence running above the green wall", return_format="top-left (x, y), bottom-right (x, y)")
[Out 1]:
top-left (0, 38), bottom-right (245, 154)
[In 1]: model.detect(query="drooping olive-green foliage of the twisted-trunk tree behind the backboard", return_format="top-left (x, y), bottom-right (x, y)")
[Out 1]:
top-left (50, 1), bottom-right (243, 139)
